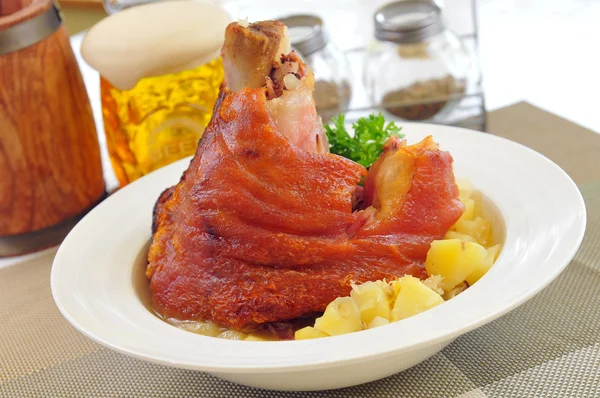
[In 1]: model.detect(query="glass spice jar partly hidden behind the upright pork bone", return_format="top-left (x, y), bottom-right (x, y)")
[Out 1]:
top-left (278, 15), bottom-right (351, 123)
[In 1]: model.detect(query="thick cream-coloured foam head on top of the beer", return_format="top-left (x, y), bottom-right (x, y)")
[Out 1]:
top-left (81, 0), bottom-right (231, 90)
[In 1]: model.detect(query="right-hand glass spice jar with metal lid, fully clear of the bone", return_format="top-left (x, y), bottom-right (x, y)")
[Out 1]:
top-left (364, 0), bottom-right (473, 121)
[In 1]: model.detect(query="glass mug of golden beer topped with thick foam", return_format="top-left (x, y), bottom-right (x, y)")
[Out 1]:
top-left (82, 0), bottom-right (230, 187)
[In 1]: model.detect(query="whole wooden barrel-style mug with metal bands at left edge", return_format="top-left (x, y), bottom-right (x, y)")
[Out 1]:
top-left (0, 0), bottom-right (105, 257)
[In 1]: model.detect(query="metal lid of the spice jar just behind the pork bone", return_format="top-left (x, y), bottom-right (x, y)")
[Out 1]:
top-left (278, 15), bottom-right (327, 57)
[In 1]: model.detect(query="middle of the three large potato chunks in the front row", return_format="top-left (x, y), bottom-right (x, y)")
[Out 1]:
top-left (350, 281), bottom-right (393, 325)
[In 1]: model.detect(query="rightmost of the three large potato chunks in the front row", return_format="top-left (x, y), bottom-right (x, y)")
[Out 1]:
top-left (392, 276), bottom-right (444, 321)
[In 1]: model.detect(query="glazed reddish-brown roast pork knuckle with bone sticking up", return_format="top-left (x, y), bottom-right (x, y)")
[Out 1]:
top-left (146, 21), bottom-right (463, 331)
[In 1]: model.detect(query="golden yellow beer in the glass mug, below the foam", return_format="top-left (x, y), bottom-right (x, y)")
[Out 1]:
top-left (100, 58), bottom-right (223, 186)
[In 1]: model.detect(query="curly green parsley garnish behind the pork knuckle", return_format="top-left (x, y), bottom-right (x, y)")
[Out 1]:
top-left (325, 113), bottom-right (404, 167)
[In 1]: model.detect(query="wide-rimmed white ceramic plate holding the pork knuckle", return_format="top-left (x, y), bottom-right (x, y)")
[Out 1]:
top-left (51, 123), bottom-right (586, 390)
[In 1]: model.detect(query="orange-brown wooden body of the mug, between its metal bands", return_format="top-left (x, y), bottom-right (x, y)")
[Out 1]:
top-left (0, 23), bottom-right (105, 236)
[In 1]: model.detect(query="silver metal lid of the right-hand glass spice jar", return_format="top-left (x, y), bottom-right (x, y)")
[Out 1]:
top-left (375, 0), bottom-right (446, 43)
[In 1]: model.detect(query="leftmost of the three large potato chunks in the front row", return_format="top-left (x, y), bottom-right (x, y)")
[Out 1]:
top-left (315, 297), bottom-right (363, 336)
